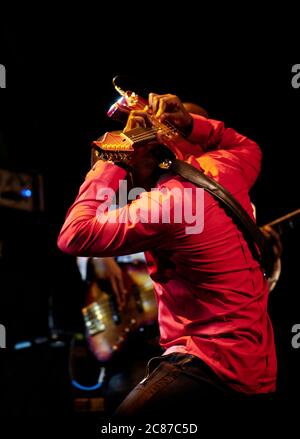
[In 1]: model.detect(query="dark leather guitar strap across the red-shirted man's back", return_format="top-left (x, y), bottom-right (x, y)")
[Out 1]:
top-left (169, 159), bottom-right (274, 276)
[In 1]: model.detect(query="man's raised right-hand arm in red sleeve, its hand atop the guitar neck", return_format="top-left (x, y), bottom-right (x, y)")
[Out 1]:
top-left (149, 93), bottom-right (262, 188)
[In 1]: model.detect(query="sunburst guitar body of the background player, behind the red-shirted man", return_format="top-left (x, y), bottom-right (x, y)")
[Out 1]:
top-left (82, 263), bottom-right (157, 362)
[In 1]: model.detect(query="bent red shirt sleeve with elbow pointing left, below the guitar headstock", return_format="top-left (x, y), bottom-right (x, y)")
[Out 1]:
top-left (58, 161), bottom-right (178, 257)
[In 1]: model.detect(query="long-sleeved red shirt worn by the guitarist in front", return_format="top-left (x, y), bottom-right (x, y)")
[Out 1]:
top-left (58, 115), bottom-right (276, 394)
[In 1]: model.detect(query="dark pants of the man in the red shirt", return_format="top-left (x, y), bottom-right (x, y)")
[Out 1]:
top-left (114, 353), bottom-right (272, 422)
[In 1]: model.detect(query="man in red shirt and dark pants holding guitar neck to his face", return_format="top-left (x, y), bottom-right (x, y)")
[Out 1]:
top-left (58, 94), bottom-right (276, 416)
